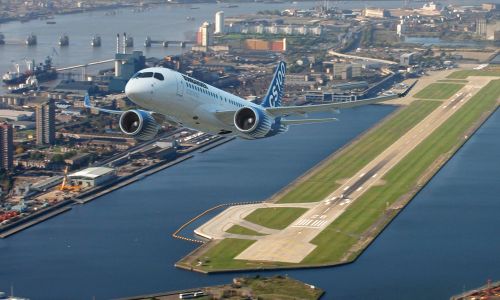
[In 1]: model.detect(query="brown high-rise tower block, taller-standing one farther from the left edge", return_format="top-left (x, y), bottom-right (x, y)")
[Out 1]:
top-left (36, 99), bottom-right (56, 145)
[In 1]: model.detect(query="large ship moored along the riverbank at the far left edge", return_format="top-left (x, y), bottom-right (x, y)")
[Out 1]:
top-left (2, 56), bottom-right (57, 85)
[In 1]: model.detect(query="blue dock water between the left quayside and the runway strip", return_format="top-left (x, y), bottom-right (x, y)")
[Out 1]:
top-left (0, 106), bottom-right (394, 299)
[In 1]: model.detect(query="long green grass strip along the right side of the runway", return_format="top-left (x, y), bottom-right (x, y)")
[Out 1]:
top-left (303, 80), bottom-right (500, 264)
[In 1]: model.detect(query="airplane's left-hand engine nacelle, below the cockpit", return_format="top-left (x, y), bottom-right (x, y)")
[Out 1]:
top-left (119, 109), bottom-right (160, 141)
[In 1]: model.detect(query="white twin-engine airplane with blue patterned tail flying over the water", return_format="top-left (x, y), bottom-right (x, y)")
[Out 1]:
top-left (84, 61), bottom-right (415, 140)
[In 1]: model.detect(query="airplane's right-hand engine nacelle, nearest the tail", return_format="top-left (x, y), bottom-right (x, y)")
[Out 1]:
top-left (234, 106), bottom-right (274, 138)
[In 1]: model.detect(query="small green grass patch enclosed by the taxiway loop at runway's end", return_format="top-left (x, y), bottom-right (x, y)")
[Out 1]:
top-left (245, 207), bottom-right (307, 229)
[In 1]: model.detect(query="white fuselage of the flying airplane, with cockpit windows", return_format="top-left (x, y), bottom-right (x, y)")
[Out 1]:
top-left (125, 67), bottom-right (259, 134)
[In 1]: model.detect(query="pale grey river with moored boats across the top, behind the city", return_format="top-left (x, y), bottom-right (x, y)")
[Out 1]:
top-left (0, 0), bottom-right (500, 86)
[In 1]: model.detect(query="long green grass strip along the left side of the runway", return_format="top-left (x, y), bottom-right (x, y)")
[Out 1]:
top-left (277, 100), bottom-right (440, 203)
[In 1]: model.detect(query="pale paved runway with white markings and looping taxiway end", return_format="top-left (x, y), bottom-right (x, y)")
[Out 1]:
top-left (197, 71), bottom-right (494, 263)
